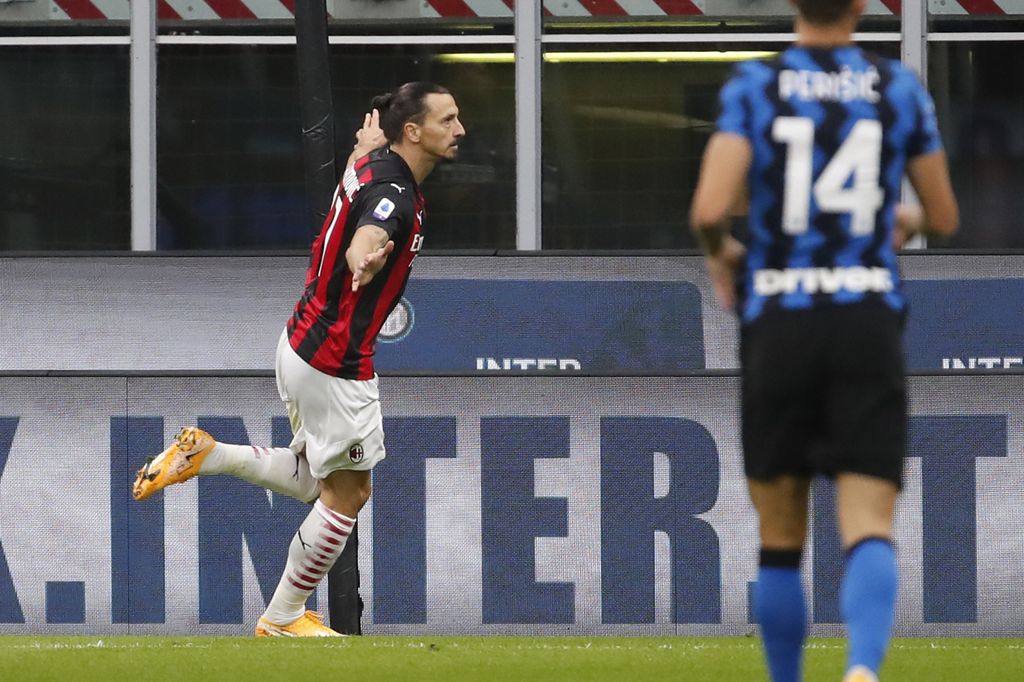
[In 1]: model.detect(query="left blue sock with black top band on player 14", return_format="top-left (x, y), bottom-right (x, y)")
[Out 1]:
top-left (754, 550), bottom-right (807, 682)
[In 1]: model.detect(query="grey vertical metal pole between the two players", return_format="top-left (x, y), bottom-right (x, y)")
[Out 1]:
top-left (515, 1), bottom-right (544, 251)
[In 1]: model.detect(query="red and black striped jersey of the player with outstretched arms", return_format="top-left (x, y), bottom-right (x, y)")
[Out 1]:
top-left (288, 147), bottom-right (424, 380)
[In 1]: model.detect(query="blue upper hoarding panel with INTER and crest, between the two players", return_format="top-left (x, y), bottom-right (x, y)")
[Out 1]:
top-left (375, 280), bottom-right (706, 372)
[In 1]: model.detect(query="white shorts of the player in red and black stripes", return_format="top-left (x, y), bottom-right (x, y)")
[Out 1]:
top-left (274, 332), bottom-right (384, 480)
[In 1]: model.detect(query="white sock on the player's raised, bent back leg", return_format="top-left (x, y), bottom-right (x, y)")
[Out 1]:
top-left (200, 442), bottom-right (319, 502)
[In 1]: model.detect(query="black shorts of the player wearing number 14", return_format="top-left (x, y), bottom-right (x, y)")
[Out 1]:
top-left (740, 302), bottom-right (907, 486)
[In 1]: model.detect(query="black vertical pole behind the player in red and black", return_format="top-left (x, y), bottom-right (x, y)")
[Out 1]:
top-left (295, 0), bottom-right (362, 635)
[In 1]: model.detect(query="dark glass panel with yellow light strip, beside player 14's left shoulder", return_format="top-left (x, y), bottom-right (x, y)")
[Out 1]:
top-left (543, 43), bottom-right (899, 249)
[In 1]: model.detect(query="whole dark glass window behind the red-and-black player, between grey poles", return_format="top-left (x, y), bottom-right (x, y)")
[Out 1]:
top-left (158, 45), bottom-right (515, 249)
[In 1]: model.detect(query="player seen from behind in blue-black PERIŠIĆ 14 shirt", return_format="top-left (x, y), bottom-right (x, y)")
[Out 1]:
top-left (690, 0), bottom-right (957, 682)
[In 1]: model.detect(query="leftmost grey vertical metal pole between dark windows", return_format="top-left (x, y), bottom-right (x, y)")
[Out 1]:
top-left (129, 2), bottom-right (157, 251)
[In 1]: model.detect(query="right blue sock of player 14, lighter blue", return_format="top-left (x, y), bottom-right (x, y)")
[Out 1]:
top-left (840, 538), bottom-right (896, 674)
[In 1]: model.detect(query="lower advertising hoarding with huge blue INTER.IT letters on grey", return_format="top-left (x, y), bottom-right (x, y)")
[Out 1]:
top-left (0, 375), bottom-right (1024, 636)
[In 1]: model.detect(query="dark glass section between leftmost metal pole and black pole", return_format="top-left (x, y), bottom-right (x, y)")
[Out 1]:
top-left (157, 45), bottom-right (299, 249)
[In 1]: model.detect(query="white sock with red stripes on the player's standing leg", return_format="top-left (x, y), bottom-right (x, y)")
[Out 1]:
top-left (263, 500), bottom-right (355, 625)
